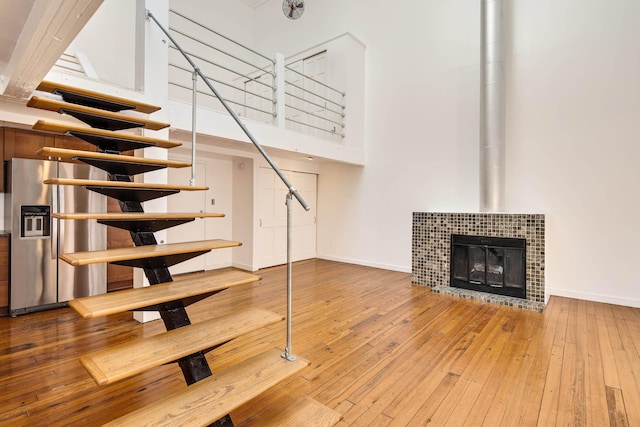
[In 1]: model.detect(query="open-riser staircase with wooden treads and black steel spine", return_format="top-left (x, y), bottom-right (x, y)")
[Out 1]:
top-left (27, 82), bottom-right (341, 426)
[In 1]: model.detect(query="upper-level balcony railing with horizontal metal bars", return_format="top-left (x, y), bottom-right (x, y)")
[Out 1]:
top-left (169, 10), bottom-right (346, 142)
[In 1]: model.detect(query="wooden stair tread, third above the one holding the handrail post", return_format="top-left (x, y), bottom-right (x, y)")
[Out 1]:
top-left (58, 239), bottom-right (242, 267)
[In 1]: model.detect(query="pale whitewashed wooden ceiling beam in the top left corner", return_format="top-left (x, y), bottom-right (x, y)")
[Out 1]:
top-left (0, 0), bottom-right (103, 98)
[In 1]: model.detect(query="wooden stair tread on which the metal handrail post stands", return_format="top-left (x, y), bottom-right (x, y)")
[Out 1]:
top-left (105, 349), bottom-right (309, 427)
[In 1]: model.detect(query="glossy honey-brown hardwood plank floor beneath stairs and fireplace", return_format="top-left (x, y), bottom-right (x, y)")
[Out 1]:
top-left (0, 260), bottom-right (640, 426)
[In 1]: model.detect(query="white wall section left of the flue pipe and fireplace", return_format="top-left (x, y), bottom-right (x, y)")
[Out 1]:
top-left (250, 0), bottom-right (479, 271)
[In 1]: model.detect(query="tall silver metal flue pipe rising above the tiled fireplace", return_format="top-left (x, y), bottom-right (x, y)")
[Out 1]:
top-left (480, 0), bottom-right (505, 212)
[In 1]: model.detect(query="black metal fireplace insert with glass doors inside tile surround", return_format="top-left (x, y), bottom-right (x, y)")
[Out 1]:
top-left (450, 234), bottom-right (527, 298)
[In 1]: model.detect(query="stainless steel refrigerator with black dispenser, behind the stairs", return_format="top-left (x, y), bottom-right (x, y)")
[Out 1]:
top-left (5, 159), bottom-right (107, 316)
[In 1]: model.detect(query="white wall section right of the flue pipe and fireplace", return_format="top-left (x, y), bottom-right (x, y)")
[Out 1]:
top-left (506, 0), bottom-right (640, 306)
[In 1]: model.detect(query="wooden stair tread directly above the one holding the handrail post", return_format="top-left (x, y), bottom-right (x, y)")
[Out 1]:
top-left (80, 308), bottom-right (284, 385)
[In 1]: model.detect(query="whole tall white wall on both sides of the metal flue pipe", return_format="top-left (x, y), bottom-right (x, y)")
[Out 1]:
top-left (250, 0), bottom-right (640, 306)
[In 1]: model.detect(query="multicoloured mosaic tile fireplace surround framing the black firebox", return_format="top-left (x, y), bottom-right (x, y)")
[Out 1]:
top-left (411, 212), bottom-right (545, 311)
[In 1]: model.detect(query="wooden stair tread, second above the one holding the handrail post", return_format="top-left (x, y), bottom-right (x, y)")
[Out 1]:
top-left (69, 270), bottom-right (261, 319)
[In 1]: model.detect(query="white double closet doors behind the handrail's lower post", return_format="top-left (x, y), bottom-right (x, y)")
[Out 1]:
top-left (256, 168), bottom-right (317, 268)
